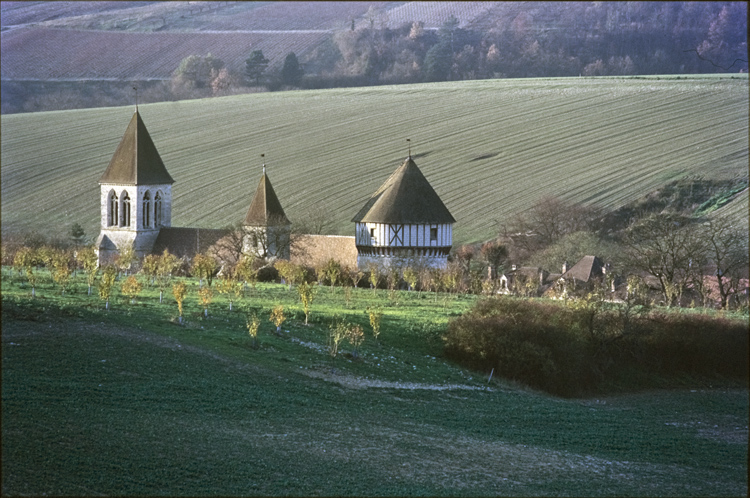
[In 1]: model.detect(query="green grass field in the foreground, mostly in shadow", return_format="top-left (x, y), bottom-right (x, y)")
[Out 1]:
top-left (2, 268), bottom-right (748, 496)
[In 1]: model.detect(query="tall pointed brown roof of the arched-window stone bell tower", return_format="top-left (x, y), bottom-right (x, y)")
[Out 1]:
top-left (99, 111), bottom-right (174, 185)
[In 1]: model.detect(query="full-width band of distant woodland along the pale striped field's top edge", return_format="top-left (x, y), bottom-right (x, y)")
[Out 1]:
top-left (2, 2), bottom-right (748, 113)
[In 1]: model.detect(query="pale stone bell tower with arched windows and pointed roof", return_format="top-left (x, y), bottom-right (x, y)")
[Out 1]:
top-left (96, 109), bottom-right (174, 264)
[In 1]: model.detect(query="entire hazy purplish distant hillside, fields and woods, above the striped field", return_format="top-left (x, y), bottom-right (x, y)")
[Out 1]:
top-left (0, 1), bottom-right (748, 114)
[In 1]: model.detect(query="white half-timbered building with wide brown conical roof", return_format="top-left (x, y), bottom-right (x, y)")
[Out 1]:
top-left (352, 154), bottom-right (456, 270)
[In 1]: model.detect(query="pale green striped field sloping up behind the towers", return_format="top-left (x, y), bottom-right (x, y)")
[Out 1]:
top-left (1, 77), bottom-right (748, 242)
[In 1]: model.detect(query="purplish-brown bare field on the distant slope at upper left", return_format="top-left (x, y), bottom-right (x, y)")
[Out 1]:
top-left (0, 28), bottom-right (330, 81)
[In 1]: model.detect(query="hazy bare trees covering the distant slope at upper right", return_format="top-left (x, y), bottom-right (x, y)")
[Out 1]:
top-left (170, 2), bottom-right (747, 98)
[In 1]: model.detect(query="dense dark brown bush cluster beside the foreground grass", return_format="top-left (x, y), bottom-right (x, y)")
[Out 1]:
top-left (443, 297), bottom-right (748, 396)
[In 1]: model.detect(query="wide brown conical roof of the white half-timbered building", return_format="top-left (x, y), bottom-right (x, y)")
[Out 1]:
top-left (352, 156), bottom-right (456, 224)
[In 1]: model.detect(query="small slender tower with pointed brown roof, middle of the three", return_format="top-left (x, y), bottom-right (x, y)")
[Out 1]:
top-left (247, 165), bottom-right (292, 259)
